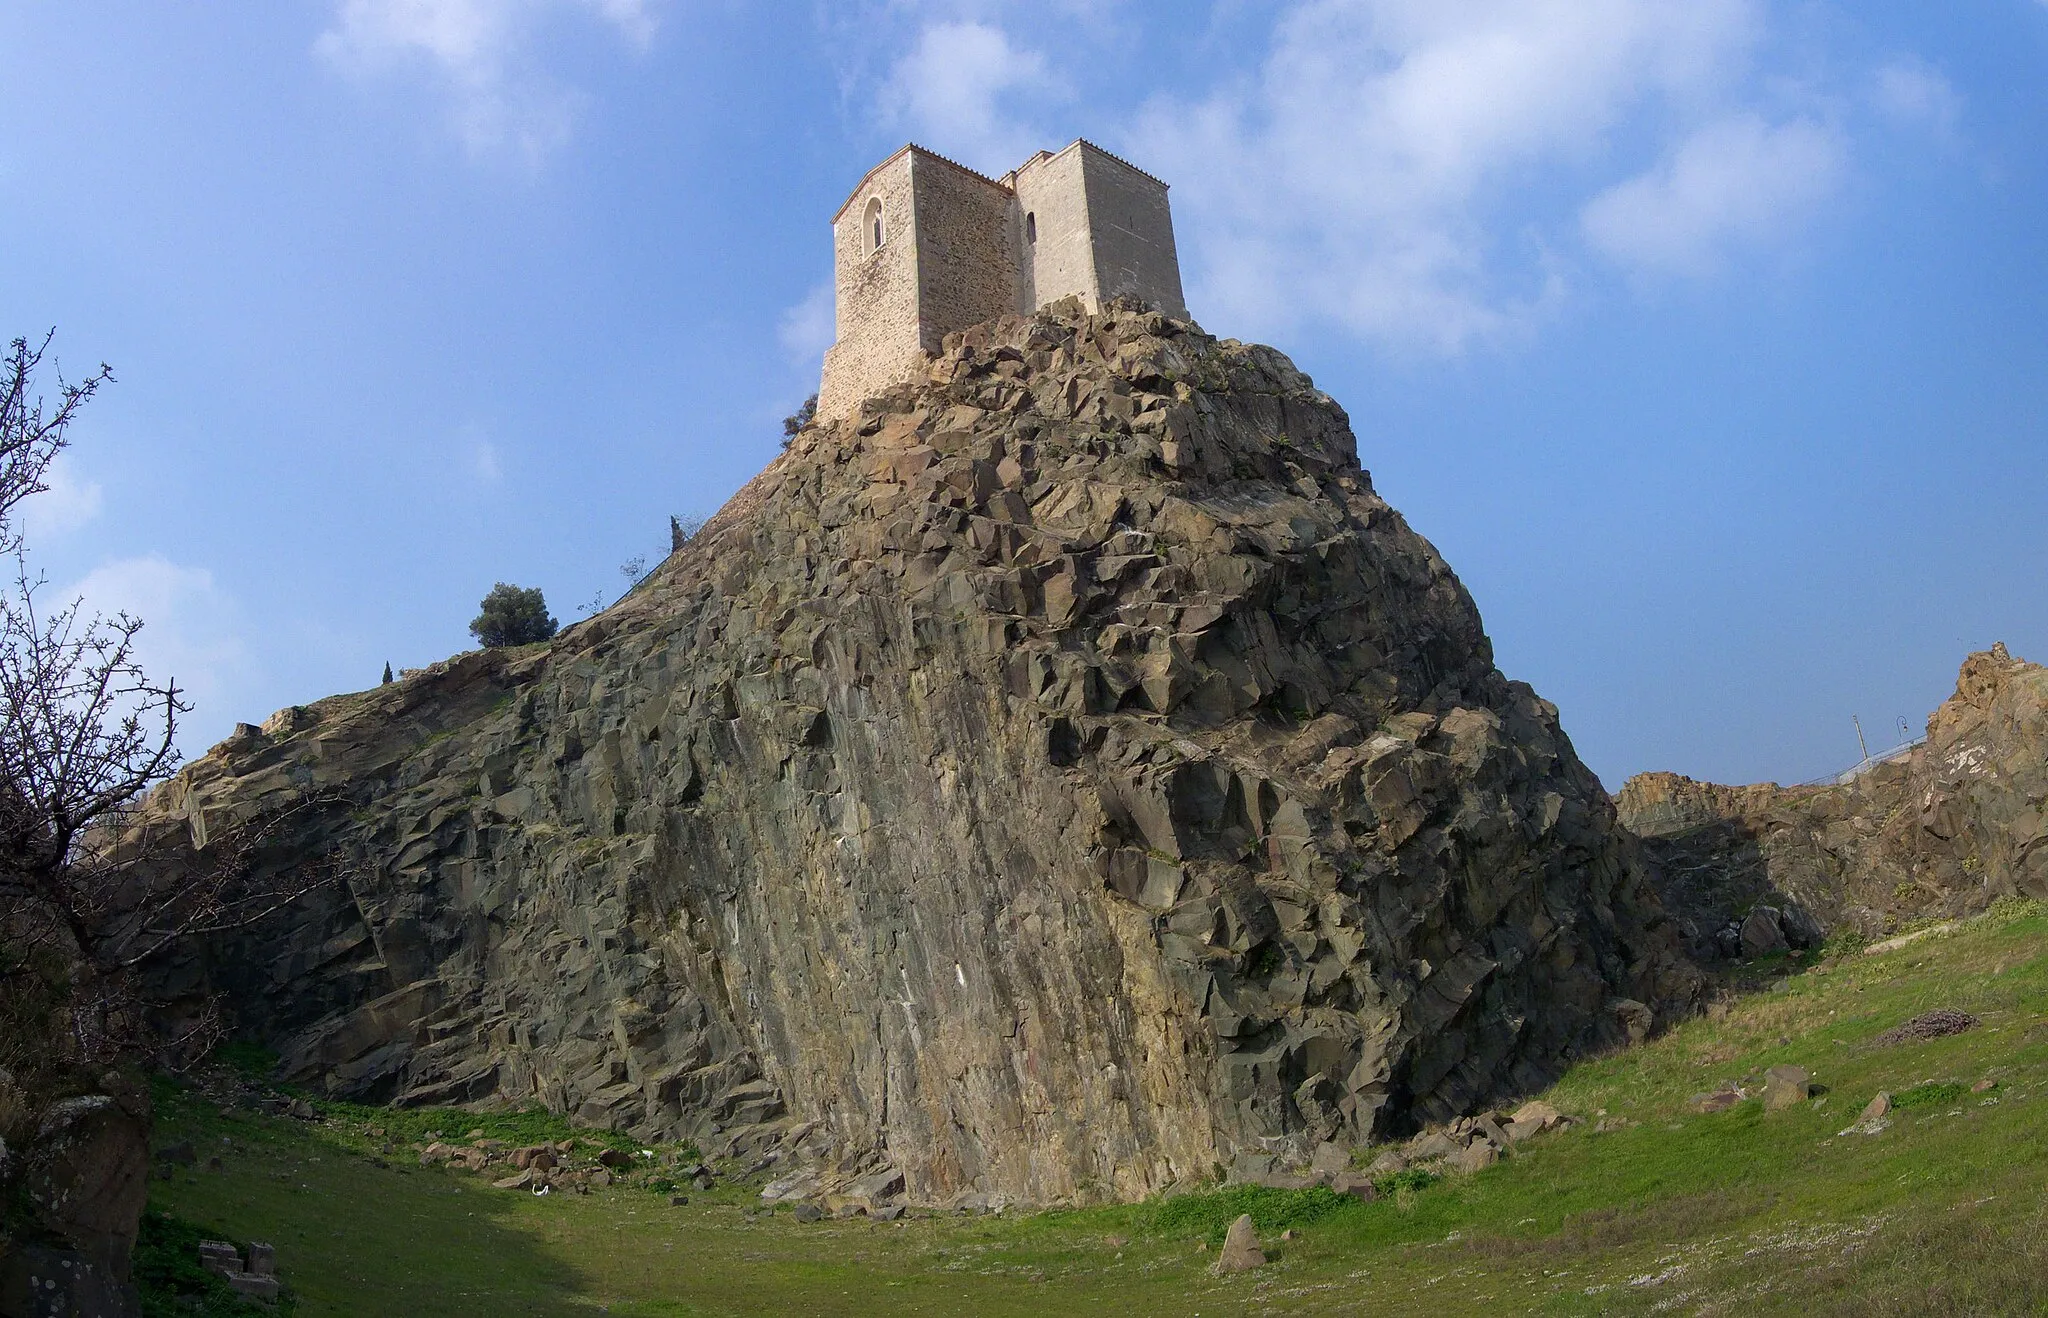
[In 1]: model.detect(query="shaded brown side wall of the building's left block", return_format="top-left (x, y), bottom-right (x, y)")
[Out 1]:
top-left (911, 156), bottom-right (1018, 352)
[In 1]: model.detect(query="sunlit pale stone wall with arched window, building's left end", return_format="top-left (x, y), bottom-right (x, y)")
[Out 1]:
top-left (817, 151), bottom-right (922, 420)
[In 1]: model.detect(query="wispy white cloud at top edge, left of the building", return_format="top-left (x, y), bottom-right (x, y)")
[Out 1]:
top-left (313, 0), bottom-right (655, 162)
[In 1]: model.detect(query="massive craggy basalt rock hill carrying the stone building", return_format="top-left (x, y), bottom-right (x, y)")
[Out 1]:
top-left (132, 305), bottom-right (1694, 1201)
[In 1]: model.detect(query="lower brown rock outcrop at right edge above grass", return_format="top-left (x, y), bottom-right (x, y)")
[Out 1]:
top-left (1616, 645), bottom-right (2048, 958)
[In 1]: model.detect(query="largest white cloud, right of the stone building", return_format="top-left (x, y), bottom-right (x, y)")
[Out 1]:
top-left (1128, 0), bottom-right (1785, 350)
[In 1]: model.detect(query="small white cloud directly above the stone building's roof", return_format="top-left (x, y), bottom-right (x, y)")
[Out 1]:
top-left (877, 23), bottom-right (1065, 174)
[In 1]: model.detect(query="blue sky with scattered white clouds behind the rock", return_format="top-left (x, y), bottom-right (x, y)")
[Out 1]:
top-left (0, 0), bottom-right (2048, 788)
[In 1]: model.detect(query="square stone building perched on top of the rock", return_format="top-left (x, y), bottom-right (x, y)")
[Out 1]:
top-left (817, 141), bottom-right (1188, 420)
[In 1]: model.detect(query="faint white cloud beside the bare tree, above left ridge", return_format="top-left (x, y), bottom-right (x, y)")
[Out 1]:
top-left (57, 555), bottom-right (252, 753)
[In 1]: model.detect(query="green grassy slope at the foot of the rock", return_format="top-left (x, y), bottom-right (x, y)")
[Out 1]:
top-left (154, 907), bottom-right (2048, 1318)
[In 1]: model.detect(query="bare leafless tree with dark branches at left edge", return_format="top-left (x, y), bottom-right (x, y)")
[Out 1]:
top-left (0, 336), bottom-right (336, 1088)
